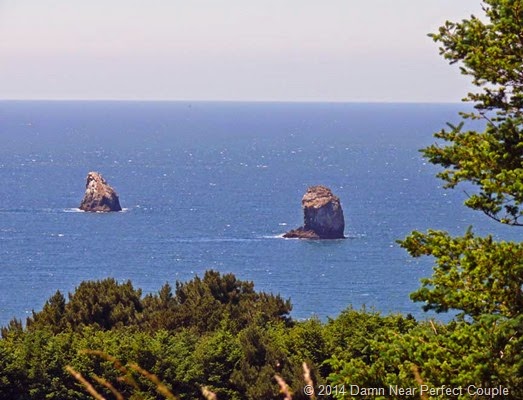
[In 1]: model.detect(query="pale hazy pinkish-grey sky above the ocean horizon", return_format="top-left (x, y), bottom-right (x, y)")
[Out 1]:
top-left (0, 0), bottom-right (481, 102)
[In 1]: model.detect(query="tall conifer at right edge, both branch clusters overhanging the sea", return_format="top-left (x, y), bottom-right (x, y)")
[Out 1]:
top-left (400, 0), bottom-right (523, 318)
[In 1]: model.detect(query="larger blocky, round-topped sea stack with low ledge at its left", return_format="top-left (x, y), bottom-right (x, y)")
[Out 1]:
top-left (283, 186), bottom-right (345, 239)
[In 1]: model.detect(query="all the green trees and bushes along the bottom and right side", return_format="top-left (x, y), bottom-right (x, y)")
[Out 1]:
top-left (0, 0), bottom-right (523, 399)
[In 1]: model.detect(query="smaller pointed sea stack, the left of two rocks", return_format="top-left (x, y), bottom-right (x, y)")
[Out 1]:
top-left (80, 172), bottom-right (122, 212)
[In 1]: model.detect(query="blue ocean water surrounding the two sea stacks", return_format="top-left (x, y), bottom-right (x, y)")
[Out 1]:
top-left (0, 101), bottom-right (517, 325)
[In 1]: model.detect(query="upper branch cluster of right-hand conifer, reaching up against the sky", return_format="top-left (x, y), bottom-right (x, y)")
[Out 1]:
top-left (423, 0), bottom-right (523, 225)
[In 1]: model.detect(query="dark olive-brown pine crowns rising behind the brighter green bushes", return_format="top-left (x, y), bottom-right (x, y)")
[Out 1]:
top-left (22, 271), bottom-right (292, 336)
